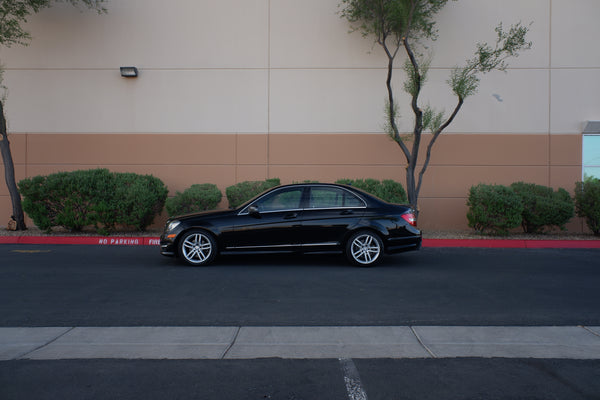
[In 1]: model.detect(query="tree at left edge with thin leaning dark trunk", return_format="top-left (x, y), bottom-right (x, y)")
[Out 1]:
top-left (0, 0), bottom-right (107, 230)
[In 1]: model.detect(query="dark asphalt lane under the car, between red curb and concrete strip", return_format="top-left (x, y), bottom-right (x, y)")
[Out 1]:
top-left (0, 245), bottom-right (600, 327)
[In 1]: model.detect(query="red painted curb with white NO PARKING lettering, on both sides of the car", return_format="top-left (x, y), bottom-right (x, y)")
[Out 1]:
top-left (0, 236), bottom-right (600, 249)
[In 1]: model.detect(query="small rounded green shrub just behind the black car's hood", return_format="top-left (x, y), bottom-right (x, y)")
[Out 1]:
top-left (165, 183), bottom-right (223, 216)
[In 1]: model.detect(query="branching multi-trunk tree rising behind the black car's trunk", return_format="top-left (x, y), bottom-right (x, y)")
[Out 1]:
top-left (339, 0), bottom-right (531, 215)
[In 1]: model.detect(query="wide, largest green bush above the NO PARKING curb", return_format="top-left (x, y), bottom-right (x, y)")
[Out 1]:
top-left (19, 169), bottom-right (168, 234)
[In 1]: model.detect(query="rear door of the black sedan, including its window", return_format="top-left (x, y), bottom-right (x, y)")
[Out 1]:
top-left (302, 186), bottom-right (366, 251)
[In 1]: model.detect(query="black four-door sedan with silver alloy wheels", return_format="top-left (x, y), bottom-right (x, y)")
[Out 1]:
top-left (160, 183), bottom-right (421, 266)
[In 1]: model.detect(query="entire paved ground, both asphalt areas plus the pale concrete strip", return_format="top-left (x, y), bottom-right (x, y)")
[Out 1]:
top-left (0, 245), bottom-right (600, 400)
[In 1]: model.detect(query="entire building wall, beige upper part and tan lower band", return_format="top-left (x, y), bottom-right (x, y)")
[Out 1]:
top-left (0, 0), bottom-right (600, 230)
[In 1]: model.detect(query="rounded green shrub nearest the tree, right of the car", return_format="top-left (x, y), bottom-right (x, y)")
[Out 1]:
top-left (467, 184), bottom-right (523, 235)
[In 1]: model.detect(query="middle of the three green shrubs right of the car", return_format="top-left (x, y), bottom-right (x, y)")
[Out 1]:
top-left (510, 182), bottom-right (575, 233)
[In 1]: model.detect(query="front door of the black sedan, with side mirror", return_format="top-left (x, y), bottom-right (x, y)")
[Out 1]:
top-left (226, 186), bottom-right (305, 251)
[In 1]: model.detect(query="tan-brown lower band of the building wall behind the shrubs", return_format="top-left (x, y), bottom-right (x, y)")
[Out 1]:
top-left (0, 134), bottom-right (581, 230)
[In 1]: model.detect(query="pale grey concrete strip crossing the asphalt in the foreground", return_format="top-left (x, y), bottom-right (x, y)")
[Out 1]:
top-left (0, 326), bottom-right (600, 360)
